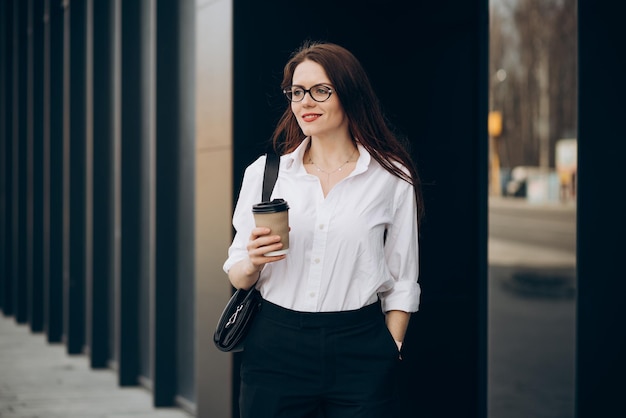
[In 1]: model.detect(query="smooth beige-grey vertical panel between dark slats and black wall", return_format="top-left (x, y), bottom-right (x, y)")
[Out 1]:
top-left (194, 0), bottom-right (233, 418)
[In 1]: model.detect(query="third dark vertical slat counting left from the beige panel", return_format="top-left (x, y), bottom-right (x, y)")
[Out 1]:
top-left (87, 0), bottom-right (117, 368)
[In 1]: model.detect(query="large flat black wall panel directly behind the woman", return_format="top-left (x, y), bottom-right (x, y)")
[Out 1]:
top-left (233, 0), bottom-right (488, 417)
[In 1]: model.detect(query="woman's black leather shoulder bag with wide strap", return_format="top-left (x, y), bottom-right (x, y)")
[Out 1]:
top-left (213, 152), bottom-right (280, 352)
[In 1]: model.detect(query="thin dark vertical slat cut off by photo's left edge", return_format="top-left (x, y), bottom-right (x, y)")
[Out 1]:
top-left (0, 1), bottom-right (10, 314)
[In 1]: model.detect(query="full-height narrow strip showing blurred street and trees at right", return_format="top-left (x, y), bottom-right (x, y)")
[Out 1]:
top-left (488, 0), bottom-right (577, 418)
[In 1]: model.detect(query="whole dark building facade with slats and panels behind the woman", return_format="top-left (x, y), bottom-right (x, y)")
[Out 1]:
top-left (0, 0), bottom-right (626, 418)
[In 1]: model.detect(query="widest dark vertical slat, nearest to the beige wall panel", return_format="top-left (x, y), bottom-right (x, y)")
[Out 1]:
top-left (150, 0), bottom-right (177, 406)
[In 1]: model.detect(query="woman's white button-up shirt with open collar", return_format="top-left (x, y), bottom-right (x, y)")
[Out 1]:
top-left (223, 139), bottom-right (420, 312)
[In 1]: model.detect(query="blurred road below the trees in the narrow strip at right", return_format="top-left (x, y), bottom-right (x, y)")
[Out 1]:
top-left (488, 199), bottom-right (576, 418)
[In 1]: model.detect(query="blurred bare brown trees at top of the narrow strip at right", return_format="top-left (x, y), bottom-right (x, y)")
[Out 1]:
top-left (490, 0), bottom-right (577, 168)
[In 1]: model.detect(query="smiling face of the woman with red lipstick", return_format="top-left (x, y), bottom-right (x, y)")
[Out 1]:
top-left (291, 61), bottom-right (349, 137)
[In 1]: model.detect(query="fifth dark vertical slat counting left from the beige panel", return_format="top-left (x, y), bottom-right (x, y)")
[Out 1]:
top-left (44, 0), bottom-right (65, 342)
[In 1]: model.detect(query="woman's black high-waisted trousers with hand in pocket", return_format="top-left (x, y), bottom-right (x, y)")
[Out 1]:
top-left (240, 301), bottom-right (399, 418)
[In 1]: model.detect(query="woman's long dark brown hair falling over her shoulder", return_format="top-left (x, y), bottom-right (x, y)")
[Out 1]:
top-left (272, 41), bottom-right (424, 222)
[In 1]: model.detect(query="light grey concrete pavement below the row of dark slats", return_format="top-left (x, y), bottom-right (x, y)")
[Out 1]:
top-left (0, 315), bottom-right (192, 418)
